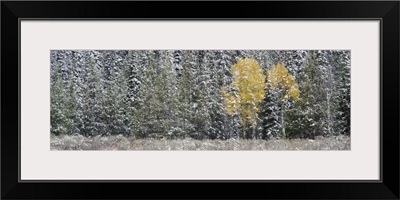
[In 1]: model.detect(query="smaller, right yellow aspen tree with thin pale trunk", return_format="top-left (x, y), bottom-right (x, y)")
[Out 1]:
top-left (267, 63), bottom-right (300, 137)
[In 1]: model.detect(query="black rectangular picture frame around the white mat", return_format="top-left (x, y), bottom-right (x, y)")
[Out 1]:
top-left (1, 1), bottom-right (400, 199)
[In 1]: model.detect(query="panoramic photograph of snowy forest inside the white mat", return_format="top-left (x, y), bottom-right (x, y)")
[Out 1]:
top-left (50, 49), bottom-right (351, 151)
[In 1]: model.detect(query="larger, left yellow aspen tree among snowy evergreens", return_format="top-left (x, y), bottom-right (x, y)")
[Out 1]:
top-left (222, 58), bottom-right (266, 138)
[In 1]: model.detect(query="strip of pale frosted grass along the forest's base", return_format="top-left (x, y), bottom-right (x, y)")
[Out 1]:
top-left (50, 134), bottom-right (350, 151)
